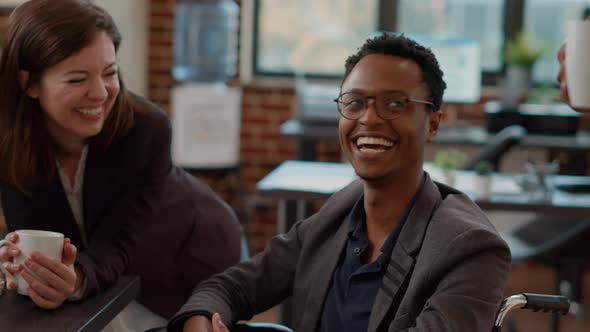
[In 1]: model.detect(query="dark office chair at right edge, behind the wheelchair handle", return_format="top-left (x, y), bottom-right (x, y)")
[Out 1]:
top-left (502, 216), bottom-right (590, 332)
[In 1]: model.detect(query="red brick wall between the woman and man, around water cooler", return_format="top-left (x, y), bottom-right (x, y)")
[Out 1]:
top-left (148, 0), bottom-right (295, 252)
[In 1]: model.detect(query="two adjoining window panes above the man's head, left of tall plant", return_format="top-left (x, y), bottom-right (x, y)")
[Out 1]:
top-left (254, 0), bottom-right (504, 77)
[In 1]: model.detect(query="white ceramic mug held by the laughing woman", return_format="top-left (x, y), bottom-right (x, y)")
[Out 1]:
top-left (0, 229), bottom-right (64, 295)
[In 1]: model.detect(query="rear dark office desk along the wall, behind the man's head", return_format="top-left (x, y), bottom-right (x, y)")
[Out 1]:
top-left (281, 119), bottom-right (590, 160)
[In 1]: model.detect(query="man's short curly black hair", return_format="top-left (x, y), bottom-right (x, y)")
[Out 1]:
top-left (342, 33), bottom-right (447, 110)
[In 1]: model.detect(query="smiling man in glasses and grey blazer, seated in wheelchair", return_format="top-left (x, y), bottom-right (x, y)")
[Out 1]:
top-left (169, 34), bottom-right (510, 332)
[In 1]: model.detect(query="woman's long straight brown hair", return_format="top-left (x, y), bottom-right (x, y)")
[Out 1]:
top-left (0, 0), bottom-right (133, 193)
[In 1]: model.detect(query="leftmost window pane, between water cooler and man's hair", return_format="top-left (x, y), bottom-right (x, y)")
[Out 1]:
top-left (254, 0), bottom-right (378, 76)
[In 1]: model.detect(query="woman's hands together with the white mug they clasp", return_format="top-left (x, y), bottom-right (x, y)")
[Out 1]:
top-left (0, 230), bottom-right (81, 309)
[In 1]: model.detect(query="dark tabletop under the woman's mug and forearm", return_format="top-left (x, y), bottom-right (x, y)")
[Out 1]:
top-left (0, 276), bottom-right (140, 332)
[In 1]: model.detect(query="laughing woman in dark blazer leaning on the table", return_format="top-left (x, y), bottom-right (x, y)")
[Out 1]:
top-left (0, 0), bottom-right (240, 330)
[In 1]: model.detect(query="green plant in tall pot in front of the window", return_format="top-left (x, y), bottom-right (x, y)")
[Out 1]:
top-left (502, 31), bottom-right (544, 109)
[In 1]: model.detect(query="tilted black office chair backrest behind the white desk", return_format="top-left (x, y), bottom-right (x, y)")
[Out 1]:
top-left (462, 125), bottom-right (526, 170)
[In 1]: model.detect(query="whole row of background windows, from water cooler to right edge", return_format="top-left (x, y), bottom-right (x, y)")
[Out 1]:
top-left (247, 0), bottom-right (590, 84)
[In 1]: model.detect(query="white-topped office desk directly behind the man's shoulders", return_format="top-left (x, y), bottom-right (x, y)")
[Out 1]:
top-left (256, 160), bottom-right (590, 232)
